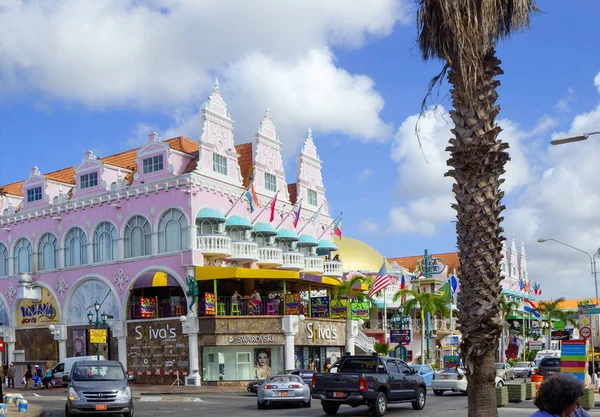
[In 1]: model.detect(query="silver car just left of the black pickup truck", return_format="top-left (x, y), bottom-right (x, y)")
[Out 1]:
top-left (256, 374), bottom-right (311, 410)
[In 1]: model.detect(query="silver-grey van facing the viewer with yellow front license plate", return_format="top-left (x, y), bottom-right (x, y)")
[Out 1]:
top-left (63, 361), bottom-right (134, 417)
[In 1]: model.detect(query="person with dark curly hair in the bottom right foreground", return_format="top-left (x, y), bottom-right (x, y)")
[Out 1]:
top-left (531, 373), bottom-right (585, 417)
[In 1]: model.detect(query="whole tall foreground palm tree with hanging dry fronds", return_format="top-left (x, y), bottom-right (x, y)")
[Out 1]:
top-left (417, 0), bottom-right (537, 417)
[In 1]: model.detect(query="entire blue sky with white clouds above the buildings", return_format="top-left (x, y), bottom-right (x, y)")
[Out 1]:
top-left (0, 0), bottom-right (600, 297)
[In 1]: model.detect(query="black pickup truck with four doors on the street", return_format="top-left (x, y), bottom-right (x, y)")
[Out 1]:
top-left (312, 355), bottom-right (427, 417)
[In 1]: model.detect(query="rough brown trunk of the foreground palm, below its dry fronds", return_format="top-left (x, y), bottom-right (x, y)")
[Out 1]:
top-left (446, 51), bottom-right (509, 417)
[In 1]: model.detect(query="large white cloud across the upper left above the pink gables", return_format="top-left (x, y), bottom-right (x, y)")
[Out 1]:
top-left (0, 0), bottom-right (409, 150)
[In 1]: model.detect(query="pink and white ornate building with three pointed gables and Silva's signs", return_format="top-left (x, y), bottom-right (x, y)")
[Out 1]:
top-left (0, 85), bottom-right (358, 384)
